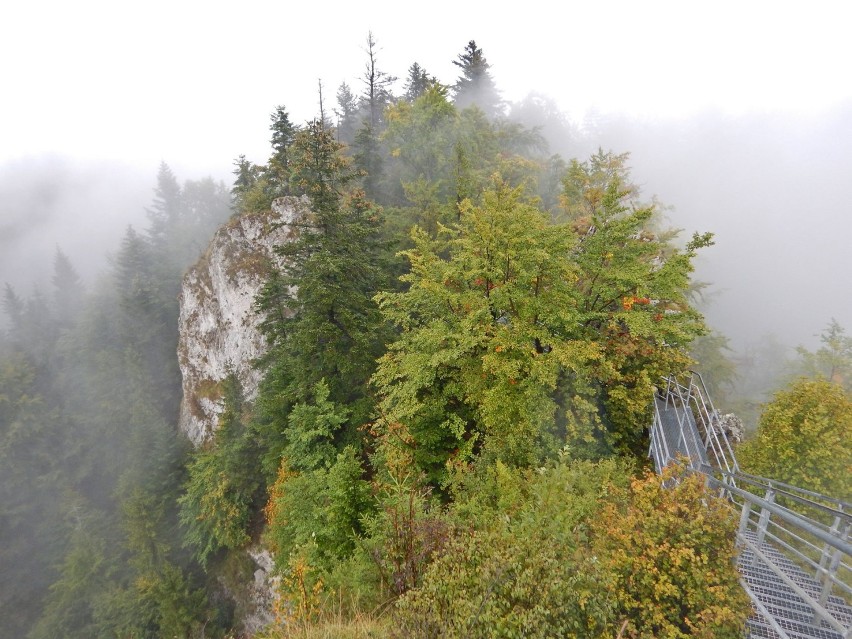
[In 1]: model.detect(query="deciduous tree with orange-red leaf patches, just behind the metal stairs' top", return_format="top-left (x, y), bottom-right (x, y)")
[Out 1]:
top-left (564, 152), bottom-right (712, 456)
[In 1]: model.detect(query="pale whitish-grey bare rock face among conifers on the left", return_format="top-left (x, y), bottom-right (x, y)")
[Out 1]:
top-left (178, 197), bottom-right (310, 446)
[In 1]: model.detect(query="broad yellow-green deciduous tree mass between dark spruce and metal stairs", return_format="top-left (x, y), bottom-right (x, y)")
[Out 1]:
top-left (374, 160), bottom-right (709, 482)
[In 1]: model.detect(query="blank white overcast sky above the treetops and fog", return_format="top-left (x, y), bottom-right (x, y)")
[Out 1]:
top-left (0, 0), bottom-right (852, 172)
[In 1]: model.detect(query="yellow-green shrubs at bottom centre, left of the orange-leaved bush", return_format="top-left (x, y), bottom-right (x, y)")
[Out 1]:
top-left (394, 463), bottom-right (624, 637)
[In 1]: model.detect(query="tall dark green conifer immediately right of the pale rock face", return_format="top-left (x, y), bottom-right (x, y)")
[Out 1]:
top-left (253, 120), bottom-right (384, 468)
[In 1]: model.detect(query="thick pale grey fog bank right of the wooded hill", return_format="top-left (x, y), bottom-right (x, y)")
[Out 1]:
top-left (588, 102), bottom-right (852, 356)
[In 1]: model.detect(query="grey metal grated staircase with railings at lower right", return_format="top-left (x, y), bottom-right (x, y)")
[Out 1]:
top-left (649, 373), bottom-right (852, 639)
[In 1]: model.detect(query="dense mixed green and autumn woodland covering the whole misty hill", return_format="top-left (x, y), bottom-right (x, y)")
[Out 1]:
top-left (5, 36), bottom-right (852, 639)
